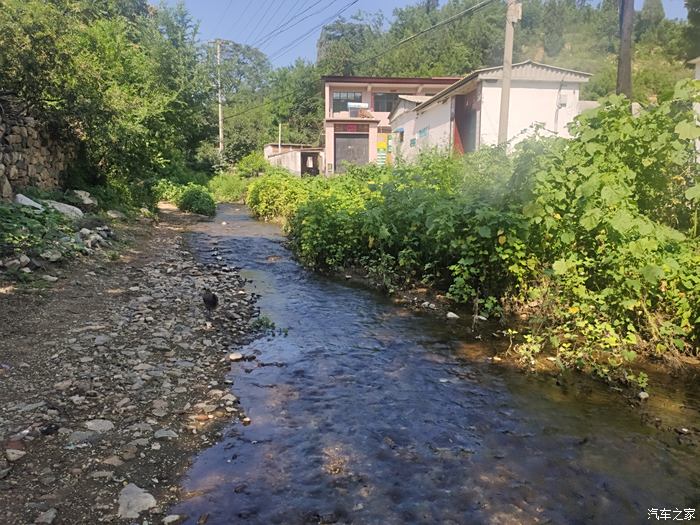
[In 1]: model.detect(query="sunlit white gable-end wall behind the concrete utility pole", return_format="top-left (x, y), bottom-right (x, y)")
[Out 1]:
top-left (480, 80), bottom-right (579, 145)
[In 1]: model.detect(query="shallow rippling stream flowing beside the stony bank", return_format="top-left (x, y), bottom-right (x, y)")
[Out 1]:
top-left (172, 206), bottom-right (700, 525)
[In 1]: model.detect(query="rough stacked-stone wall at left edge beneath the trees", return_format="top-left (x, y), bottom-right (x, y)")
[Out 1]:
top-left (0, 113), bottom-right (75, 200)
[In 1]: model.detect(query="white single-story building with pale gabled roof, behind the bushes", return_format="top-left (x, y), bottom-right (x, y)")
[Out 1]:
top-left (389, 60), bottom-right (596, 160)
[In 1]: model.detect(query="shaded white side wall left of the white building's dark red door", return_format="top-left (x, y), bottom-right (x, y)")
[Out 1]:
top-left (391, 99), bottom-right (452, 162)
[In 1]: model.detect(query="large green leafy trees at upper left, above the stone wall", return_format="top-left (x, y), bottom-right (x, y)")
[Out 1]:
top-left (0, 0), bottom-right (211, 206)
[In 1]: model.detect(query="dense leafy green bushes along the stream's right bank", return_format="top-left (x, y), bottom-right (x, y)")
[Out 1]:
top-left (247, 82), bottom-right (700, 385)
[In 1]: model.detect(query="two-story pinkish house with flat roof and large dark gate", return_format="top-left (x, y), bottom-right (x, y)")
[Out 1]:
top-left (323, 76), bottom-right (460, 175)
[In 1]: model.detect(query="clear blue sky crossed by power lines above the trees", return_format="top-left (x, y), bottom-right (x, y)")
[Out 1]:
top-left (167, 0), bottom-right (687, 66)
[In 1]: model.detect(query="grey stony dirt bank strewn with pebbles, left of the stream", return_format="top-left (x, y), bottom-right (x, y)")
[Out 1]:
top-left (0, 207), bottom-right (255, 524)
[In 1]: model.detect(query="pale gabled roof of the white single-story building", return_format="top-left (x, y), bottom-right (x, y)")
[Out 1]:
top-left (416, 60), bottom-right (592, 111)
